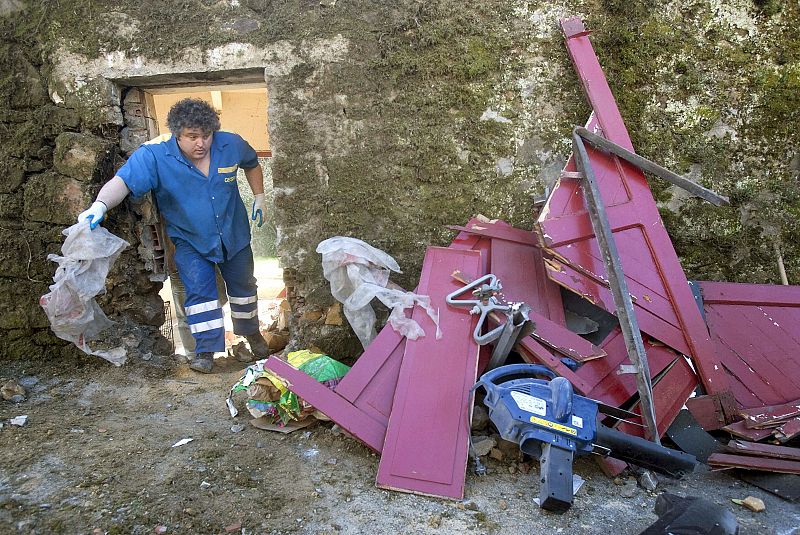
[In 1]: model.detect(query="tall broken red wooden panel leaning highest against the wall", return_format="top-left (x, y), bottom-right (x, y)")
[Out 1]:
top-left (538, 19), bottom-right (730, 402)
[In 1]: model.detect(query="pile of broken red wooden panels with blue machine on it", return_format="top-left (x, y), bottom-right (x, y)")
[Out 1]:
top-left (266, 15), bottom-right (800, 520)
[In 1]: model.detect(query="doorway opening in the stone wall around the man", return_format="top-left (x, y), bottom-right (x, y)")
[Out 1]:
top-left (125, 83), bottom-right (288, 360)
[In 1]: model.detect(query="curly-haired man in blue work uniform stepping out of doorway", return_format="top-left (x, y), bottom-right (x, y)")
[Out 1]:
top-left (78, 99), bottom-right (269, 373)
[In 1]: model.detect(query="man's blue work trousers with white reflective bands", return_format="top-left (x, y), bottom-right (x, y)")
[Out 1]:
top-left (173, 239), bottom-right (258, 353)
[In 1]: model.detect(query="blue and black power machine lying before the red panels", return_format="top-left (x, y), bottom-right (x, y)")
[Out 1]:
top-left (474, 364), bottom-right (697, 512)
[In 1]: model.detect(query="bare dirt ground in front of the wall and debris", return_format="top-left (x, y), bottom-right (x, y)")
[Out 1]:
top-left (0, 357), bottom-right (800, 535)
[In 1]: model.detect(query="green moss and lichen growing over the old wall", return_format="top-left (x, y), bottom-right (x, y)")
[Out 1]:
top-left (0, 0), bottom-right (800, 360)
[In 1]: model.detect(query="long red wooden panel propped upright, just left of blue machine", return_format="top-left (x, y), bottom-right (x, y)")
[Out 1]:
top-left (377, 247), bottom-right (480, 499)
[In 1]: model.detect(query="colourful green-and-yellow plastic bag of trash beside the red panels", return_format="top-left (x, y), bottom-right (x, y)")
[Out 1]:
top-left (227, 350), bottom-right (350, 424)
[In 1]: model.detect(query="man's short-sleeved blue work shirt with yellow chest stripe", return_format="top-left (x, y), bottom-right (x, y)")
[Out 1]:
top-left (117, 131), bottom-right (258, 263)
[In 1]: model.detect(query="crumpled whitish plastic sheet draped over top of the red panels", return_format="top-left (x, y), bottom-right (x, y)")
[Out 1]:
top-left (317, 236), bottom-right (442, 349)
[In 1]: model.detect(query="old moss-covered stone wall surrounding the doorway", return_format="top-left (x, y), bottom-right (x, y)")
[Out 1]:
top-left (0, 0), bottom-right (800, 362)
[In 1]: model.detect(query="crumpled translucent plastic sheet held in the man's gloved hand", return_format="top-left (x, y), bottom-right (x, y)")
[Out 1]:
top-left (39, 222), bottom-right (129, 366)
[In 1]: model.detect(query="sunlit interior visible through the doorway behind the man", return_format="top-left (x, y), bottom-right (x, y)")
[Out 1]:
top-left (147, 84), bottom-right (284, 354)
